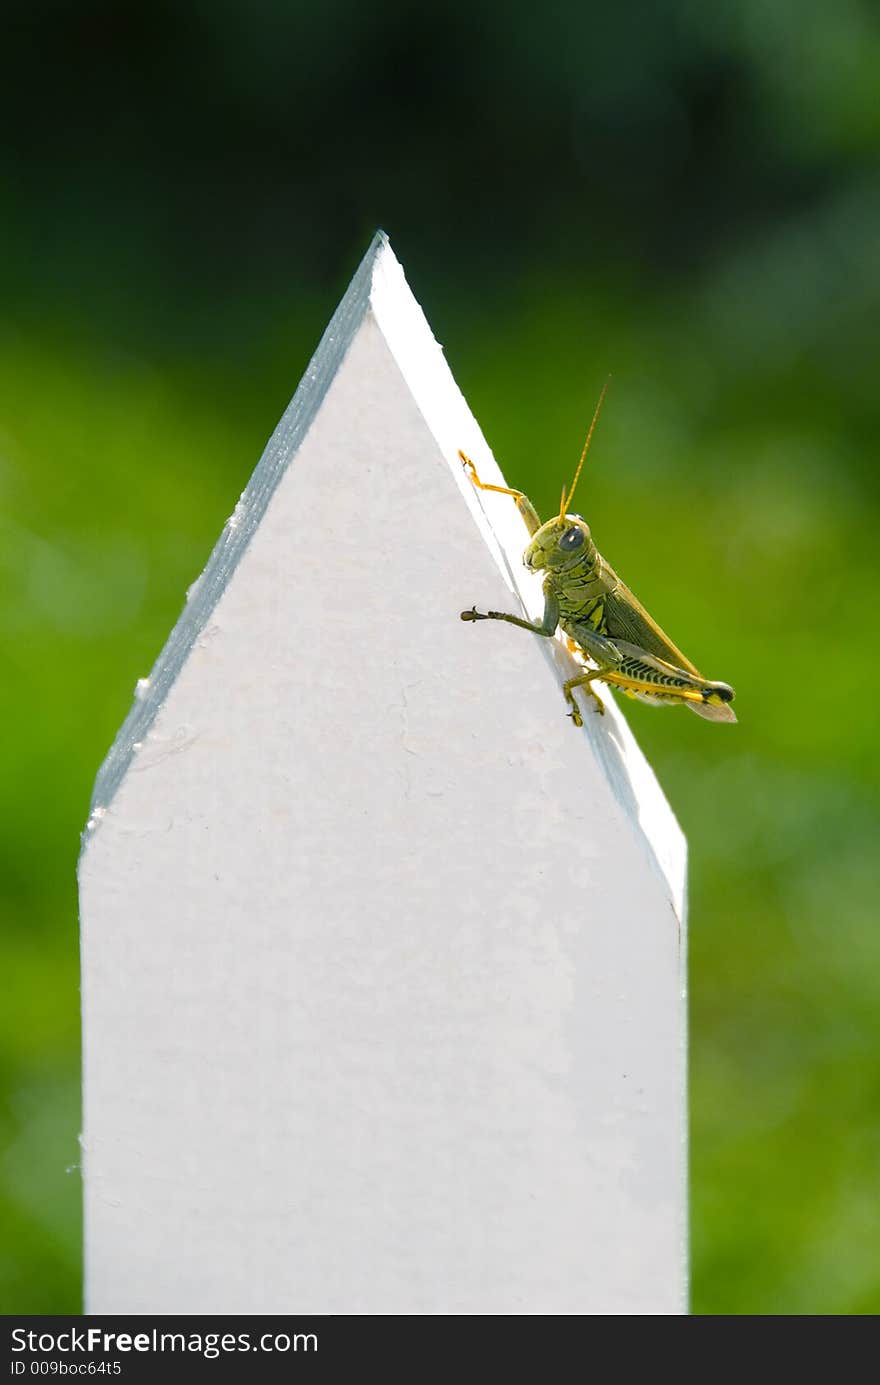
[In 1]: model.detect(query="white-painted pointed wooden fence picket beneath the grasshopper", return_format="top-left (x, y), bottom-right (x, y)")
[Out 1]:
top-left (80, 235), bottom-right (686, 1314)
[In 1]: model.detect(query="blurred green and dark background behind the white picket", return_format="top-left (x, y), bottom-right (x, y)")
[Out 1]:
top-left (0, 0), bottom-right (880, 1314)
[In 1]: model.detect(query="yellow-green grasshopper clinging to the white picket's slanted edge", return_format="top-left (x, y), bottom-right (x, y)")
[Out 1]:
top-left (459, 381), bottom-right (736, 726)
